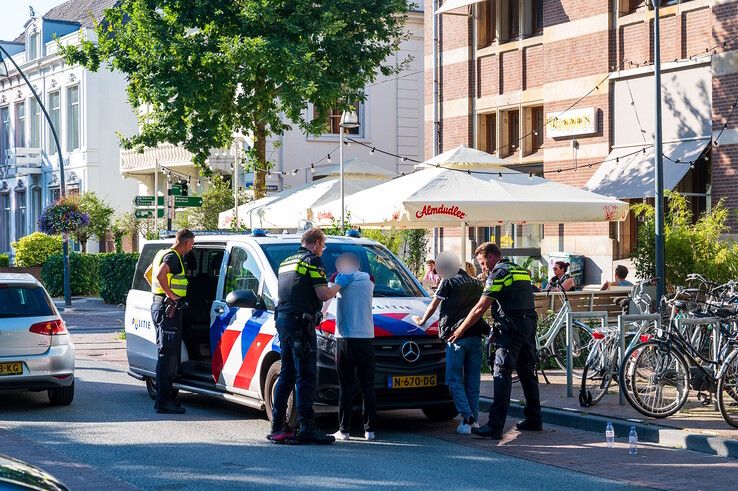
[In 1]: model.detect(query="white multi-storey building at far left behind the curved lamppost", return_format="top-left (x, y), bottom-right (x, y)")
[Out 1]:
top-left (0, 0), bottom-right (137, 256)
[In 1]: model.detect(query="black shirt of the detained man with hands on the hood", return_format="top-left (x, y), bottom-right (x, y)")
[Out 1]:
top-left (435, 269), bottom-right (489, 339)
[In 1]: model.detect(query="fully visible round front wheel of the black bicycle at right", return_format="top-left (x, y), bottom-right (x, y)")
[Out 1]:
top-left (620, 341), bottom-right (689, 418)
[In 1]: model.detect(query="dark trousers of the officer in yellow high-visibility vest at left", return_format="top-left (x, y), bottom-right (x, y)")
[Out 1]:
top-left (151, 297), bottom-right (182, 404)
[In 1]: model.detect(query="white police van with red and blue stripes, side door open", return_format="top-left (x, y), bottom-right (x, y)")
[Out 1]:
top-left (125, 231), bottom-right (456, 422)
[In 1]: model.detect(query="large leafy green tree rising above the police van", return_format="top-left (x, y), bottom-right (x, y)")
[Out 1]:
top-left (60, 0), bottom-right (408, 198)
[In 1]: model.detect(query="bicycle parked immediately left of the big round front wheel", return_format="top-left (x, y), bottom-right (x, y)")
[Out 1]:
top-left (579, 278), bottom-right (654, 407)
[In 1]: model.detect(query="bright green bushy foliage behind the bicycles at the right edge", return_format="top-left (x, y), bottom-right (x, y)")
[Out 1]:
top-left (632, 193), bottom-right (738, 287)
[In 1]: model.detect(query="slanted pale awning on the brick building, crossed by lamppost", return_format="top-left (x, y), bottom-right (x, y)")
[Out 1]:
top-left (584, 140), bottom-right (709, 199)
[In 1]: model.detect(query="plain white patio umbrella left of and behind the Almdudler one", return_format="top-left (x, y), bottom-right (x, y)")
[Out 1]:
top-left (218, 159), bottom-right (394, 229)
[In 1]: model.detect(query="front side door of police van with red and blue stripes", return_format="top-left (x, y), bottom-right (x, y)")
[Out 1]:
top-left (210, 244), bottom-right (273, 392)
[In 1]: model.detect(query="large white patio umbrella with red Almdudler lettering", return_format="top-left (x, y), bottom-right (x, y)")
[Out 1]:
top-left (314, 147), bottom-right (628, 260)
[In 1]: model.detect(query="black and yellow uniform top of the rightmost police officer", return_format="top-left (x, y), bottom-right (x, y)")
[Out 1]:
top-left (484, 258), bottom-right (535, 314)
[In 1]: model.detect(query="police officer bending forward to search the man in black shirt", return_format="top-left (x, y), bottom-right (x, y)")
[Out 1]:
top-left (449, 242), bottom-right (543, 440)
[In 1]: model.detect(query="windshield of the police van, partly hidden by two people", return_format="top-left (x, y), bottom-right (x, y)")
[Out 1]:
top-left (260, 243), bottom-right (425, 297)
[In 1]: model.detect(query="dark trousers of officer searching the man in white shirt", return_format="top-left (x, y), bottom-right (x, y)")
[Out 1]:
top-left (267, 318), bottom-right (318, 425)
